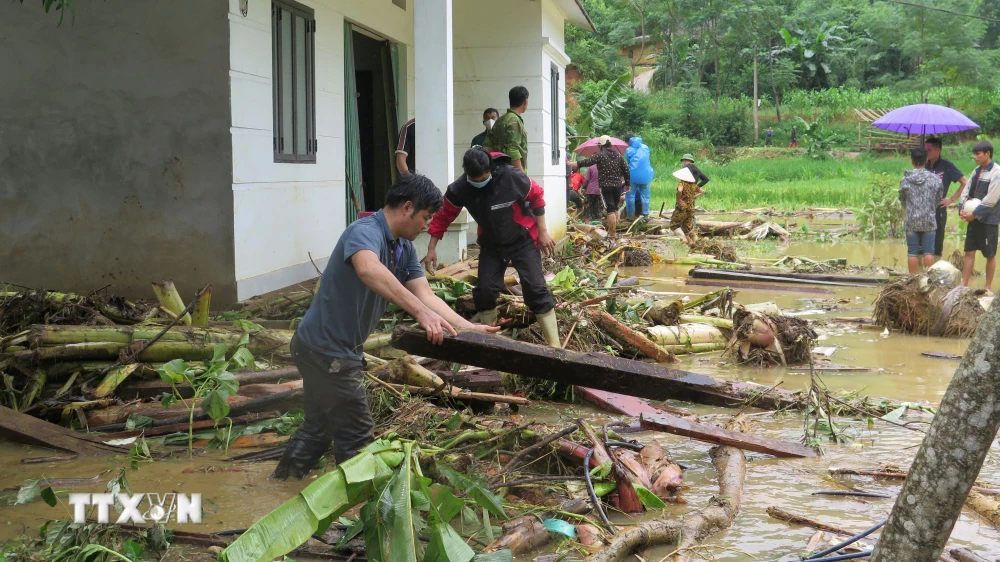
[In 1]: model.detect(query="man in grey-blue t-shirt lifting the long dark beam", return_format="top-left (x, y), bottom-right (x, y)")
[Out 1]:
top-left (271, 174), bottom-right (499, 480)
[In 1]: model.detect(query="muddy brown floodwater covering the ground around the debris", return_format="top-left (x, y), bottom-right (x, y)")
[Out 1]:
top-left (0, 224), bottom-right (1000, 561)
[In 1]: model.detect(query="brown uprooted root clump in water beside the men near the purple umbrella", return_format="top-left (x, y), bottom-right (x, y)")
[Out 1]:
top-left (873, 261), bottom-right (989, 338)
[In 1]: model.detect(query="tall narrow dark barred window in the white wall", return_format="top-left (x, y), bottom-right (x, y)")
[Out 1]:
top-left (271, 0), bottom-right (317, 163)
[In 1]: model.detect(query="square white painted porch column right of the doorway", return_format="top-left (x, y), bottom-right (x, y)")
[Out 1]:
top-left (413, 0), bottom-right (468, 263)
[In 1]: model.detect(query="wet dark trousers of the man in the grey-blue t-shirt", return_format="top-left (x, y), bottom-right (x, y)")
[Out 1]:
top-left (288, 336), bottom-right (375, 464)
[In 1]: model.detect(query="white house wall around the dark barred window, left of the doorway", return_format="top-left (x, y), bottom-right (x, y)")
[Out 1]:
top-left (229, 0), bottom-right (416, 299)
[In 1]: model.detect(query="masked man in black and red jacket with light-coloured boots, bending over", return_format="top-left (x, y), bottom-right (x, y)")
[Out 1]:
top-left (423, 147), bottom-right (562, 347)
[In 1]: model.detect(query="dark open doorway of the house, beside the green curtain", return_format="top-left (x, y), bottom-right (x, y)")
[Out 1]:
top-left (351, 29), bottom-right (399, 211)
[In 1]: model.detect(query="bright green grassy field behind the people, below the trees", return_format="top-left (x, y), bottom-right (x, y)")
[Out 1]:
top-left (651, 146), bottom-right (975, 213)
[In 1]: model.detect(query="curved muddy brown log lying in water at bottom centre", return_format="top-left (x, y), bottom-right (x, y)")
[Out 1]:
top-left (587, 418), bottom-right (747, 562)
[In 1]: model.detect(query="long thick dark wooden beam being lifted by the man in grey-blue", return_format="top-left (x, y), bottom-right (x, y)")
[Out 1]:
top-left (392, 326), bottom-right (805, 408)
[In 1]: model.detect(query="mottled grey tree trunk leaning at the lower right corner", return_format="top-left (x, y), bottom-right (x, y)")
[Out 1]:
top-left (871, 296), bottom-right (1000, 562)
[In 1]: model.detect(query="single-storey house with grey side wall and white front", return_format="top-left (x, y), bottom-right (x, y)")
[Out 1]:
top-left (0, 0), bottom-right (593, 304)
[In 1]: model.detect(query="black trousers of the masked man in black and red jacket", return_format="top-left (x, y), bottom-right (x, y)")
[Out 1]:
top-left (472, 239), bottom-right (553, 314)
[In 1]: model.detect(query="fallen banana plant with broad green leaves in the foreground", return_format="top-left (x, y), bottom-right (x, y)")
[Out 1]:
top-left (219, 440), bottom-right (507, 562)
